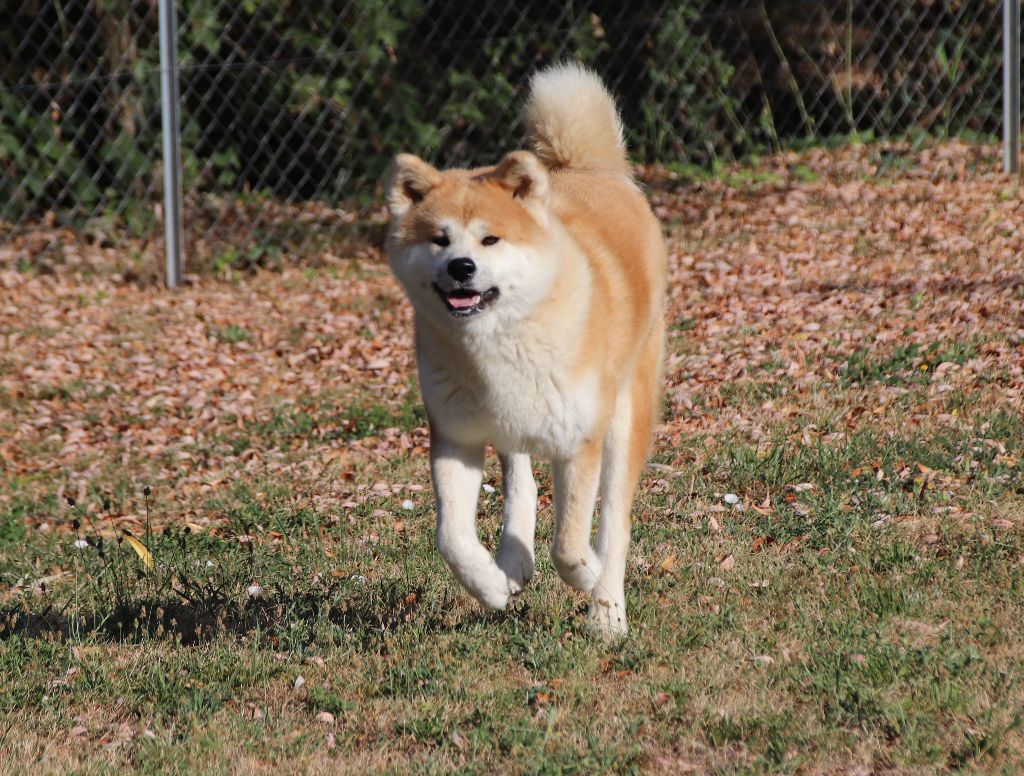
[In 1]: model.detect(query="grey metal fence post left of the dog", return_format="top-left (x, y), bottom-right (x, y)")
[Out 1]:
top-left (160, 0), bottom-right (182, 289)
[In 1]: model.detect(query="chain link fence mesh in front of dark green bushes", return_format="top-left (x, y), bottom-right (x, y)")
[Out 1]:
top-left (0, 0), bottom-right (1015, 270)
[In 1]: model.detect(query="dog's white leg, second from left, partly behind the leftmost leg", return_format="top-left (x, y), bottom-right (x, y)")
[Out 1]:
top-left (498, 452), bottom-right (537, 593)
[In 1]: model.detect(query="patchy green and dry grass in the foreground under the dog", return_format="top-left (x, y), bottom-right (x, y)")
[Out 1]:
top-left (0, 397), bottom-right (1024, 773)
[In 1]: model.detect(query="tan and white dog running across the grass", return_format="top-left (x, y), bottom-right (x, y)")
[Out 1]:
top-left (388, 64), bottom-right (666, 637)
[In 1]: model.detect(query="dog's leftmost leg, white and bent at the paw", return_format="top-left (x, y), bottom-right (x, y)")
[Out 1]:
top-left (430, 432), bottom-right (514, 609)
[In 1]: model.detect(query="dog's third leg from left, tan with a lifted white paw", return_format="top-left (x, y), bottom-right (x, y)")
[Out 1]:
top-left (551, 439), bottom-right (601, 593)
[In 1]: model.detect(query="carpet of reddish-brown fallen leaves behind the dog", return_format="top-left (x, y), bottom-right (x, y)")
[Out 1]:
top-left (0, 142), bottom-right (1024, 536)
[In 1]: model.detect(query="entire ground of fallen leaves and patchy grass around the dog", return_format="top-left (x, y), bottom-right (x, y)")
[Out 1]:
top-left (0, 143), bottom-right (1024, 773)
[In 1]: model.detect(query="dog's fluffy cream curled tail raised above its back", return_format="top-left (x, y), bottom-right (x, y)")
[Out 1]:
top-left (524, 62), bottom-right (630, 175)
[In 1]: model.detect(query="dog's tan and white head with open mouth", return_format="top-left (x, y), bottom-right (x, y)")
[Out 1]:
top-left (388, 152), bottom-right (557, 331)
